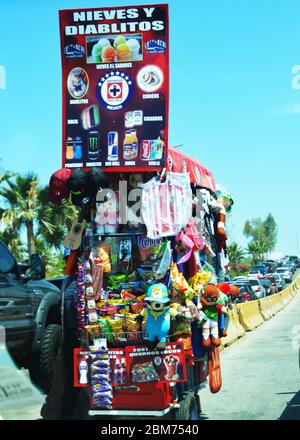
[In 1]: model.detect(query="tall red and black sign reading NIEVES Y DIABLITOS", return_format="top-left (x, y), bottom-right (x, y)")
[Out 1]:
top-left (59, 5), bottom-right (169, 172)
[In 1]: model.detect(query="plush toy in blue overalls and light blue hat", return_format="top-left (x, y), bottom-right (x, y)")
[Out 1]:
top-left (137, 283), bottom-right (176, 350)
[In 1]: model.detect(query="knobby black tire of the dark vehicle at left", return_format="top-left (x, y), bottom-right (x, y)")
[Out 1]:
top-left (40, 324), bottom-right (62, 393)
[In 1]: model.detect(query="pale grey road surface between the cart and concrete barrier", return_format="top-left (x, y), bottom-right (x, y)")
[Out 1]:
top-left (200, 292), bottom-right (300, 420)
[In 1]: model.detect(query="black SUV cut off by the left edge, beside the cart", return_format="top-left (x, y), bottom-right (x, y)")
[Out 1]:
top-left (0, 241), bottom-right (61, 391)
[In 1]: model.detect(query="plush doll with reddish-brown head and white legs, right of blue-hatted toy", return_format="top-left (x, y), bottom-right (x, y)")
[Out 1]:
top-left (200, 284), bottom-right (227, 348)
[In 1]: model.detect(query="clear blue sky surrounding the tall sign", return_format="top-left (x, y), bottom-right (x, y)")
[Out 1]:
top-left (0, 0), bottom-right (300, 254)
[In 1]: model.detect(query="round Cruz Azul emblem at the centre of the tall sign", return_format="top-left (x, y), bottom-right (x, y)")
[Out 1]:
top-left (97, 70), bottom-right (134, 110)
